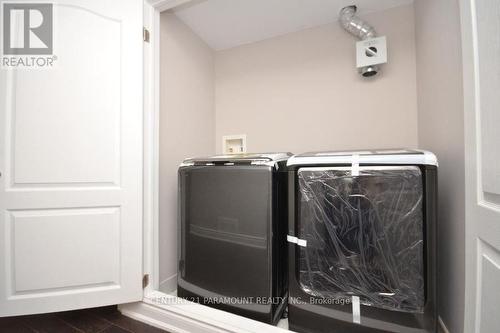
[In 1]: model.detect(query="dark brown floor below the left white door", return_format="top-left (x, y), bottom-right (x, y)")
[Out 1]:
top-left (0, 306), bottom-right (170, 333)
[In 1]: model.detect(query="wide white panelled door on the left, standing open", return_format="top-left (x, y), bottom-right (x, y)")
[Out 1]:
top-left (0, 0), bottom-right (143, 316)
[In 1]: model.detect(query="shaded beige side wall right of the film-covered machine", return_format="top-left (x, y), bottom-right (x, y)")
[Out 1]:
top-left (415, 0), bottom-right (465, 333)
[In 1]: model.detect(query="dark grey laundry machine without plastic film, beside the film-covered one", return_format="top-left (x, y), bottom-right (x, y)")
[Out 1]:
top-left (177, 153), bottom-right (291, 324)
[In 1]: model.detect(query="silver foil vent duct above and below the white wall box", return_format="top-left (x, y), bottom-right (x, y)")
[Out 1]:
top-left (340, 6), bottom-right (379, 77)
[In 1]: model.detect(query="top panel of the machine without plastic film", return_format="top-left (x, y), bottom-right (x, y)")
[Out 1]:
top-left (181, 153), bottom-right (292, 166)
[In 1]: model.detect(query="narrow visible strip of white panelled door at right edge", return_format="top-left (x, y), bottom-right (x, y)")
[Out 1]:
top-left (460, 0), bottom-right (500, 333)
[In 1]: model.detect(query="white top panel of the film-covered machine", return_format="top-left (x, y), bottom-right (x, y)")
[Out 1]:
top-left (287, 149), bottom-right (438, 166)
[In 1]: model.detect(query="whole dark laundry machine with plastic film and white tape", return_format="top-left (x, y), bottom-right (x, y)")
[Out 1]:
top-left (287, 150), bottom-right (437, 333)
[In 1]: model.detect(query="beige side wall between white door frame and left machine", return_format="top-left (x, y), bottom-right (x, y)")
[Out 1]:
top-left (159, 13), bottom-right (215, 291)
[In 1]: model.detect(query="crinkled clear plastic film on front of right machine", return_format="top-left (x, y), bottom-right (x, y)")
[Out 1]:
top-left (298, 166), bottom-right (425, 313)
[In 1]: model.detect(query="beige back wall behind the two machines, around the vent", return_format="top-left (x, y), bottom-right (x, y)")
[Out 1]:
top-left (216, 5), bottom-right (417, 153)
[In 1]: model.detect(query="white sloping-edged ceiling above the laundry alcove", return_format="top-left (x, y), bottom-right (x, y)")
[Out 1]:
top-left (172, 0), bottom-right (413, 50)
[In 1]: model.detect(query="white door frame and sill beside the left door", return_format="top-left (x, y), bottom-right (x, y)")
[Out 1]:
top-left (119, 0), bottom-right (290, 333)
